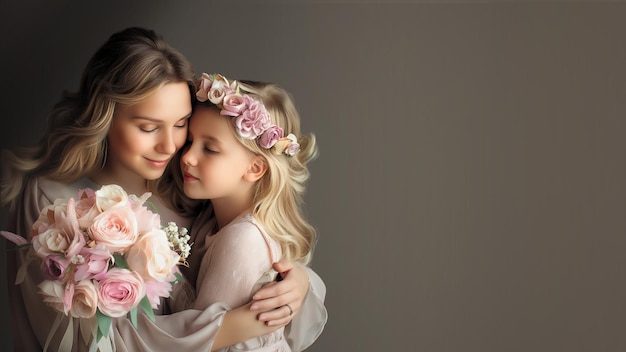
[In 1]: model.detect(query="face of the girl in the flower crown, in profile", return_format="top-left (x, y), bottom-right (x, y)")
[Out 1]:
top-left (180, 106), bottom-right (255, 201)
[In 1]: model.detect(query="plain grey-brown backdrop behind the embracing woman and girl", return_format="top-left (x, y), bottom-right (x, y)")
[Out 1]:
top-left (0, 0), bottom-right (626, 352)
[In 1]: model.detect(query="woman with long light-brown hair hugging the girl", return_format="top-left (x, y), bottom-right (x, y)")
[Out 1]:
top-left (0, 28), bottom-right (324, 351)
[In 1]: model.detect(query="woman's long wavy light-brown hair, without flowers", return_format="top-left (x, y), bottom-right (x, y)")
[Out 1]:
top-left (0, 27), bottom-right (195, 212)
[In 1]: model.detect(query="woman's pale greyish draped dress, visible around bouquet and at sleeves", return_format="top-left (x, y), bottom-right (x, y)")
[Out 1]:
top-left (7, 178), bottom-right (327, 352)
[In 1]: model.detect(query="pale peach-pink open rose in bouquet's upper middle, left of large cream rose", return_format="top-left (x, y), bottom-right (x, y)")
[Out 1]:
top-left (89, 206), bottom-right (138, 253)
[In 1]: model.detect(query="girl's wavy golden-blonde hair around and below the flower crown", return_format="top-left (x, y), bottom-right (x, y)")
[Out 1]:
top-left (207, 80), bottom-right (318, 264)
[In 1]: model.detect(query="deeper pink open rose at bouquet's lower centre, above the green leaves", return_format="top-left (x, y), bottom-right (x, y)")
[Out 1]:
top-left (96, 267), bottom-right (146, 318)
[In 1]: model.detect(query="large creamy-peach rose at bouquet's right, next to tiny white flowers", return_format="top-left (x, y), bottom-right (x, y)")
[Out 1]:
top-left (126, 229), bottom-right (180, 282)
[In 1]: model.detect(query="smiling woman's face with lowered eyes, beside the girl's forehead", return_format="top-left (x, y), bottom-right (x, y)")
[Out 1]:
top-left (105, 82), bottom-right (191, 180)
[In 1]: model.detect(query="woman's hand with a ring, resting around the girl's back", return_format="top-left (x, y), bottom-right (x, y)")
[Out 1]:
top-left (250, 260), bottom-right (309, 326)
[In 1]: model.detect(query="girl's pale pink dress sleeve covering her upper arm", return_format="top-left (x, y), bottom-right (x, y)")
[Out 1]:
top-left (194, 221), bottom-right (277, 309)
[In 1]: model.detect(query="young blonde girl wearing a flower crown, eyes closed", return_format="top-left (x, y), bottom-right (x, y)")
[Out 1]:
top-left (181, 74), bottom-right (317, 351)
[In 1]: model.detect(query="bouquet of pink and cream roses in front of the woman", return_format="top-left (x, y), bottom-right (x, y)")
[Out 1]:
top-left (2, 185), bottom-right (191, 350)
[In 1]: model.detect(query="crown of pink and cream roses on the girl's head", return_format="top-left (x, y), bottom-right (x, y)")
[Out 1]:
top-left (196, 73), bottom-right (300, 156)
